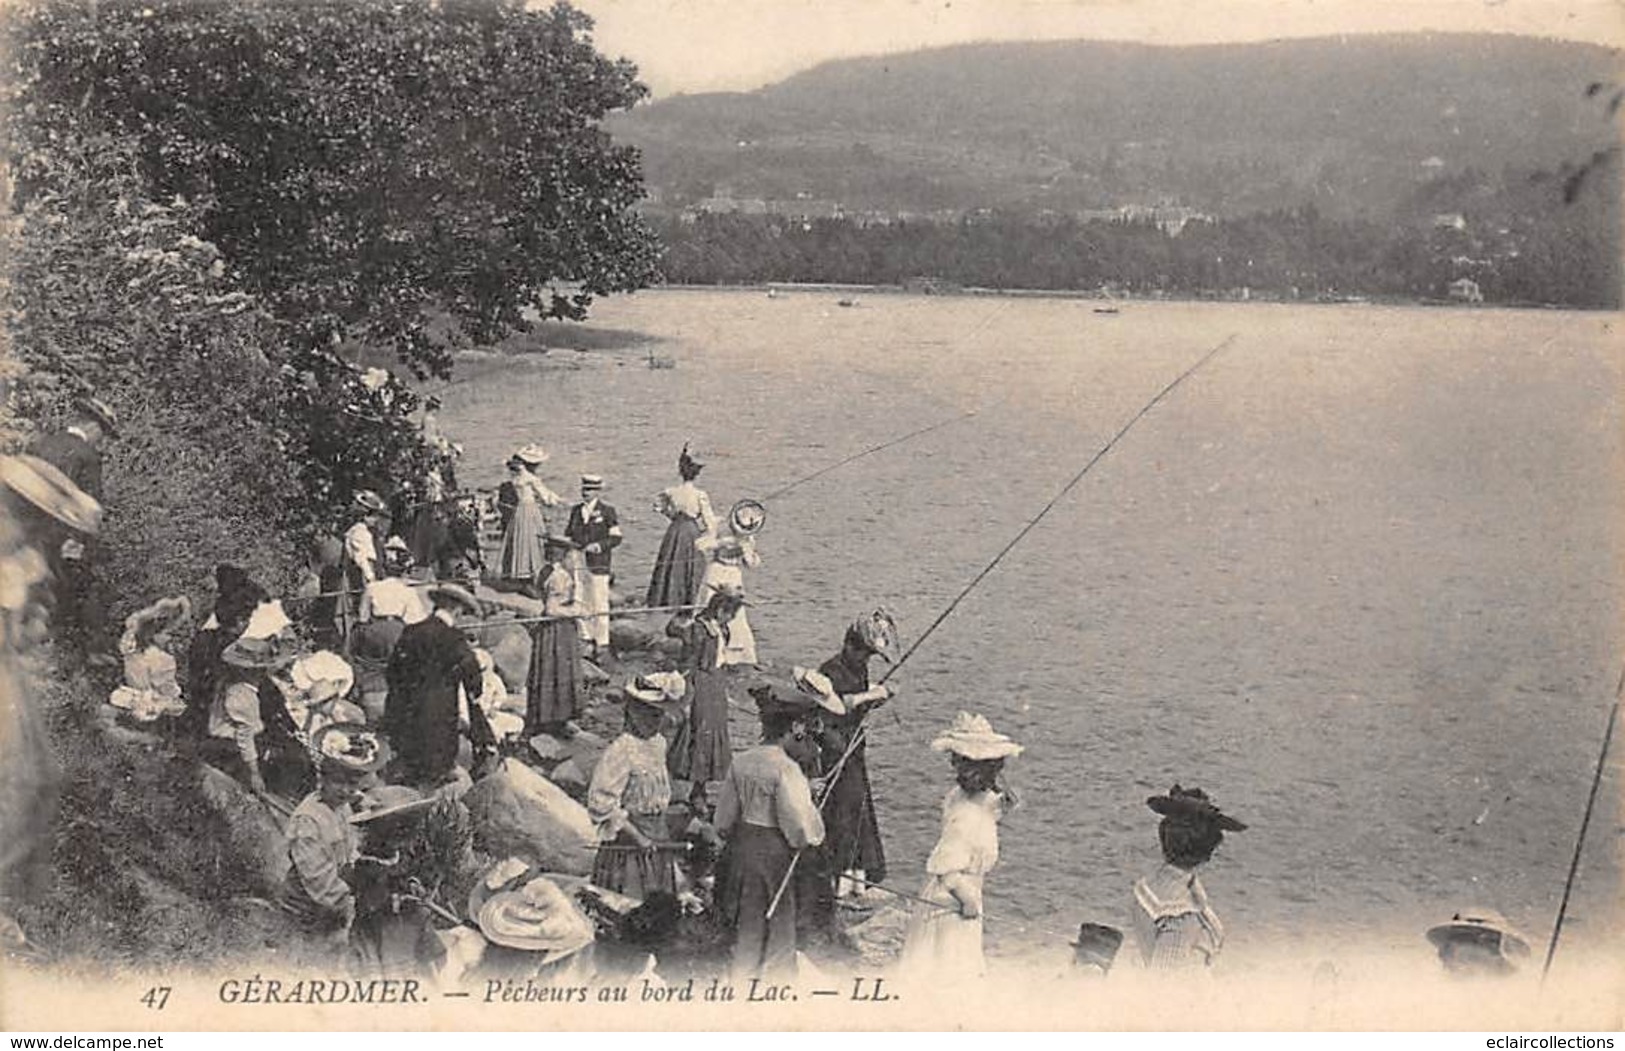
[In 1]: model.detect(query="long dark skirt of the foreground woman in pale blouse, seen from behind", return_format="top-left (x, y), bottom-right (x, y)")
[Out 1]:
top-left (725, 824), bottom-right (796, 978)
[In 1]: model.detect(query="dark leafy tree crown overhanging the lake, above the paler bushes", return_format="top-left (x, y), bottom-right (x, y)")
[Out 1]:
top-left (16, 0), bottom-right (655, 375)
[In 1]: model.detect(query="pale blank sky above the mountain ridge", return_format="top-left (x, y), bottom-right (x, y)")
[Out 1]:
top-left (572, 0), bottom-right (1625, 97)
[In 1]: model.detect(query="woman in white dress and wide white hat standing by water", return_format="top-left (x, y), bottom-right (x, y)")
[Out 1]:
top-left (900, 711), bottom-right (1022, 983)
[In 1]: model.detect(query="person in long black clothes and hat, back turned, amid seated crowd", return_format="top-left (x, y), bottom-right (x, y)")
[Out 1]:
top-left (384, 585), bottom-right (496, 788)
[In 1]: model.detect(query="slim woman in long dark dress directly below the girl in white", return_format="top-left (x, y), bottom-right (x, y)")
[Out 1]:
top-left (668, 586), bottom-right (744, 806)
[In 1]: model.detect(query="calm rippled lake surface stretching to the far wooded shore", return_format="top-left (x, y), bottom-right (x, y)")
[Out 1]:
top-left (440, 289), bottom-right (1625, 970)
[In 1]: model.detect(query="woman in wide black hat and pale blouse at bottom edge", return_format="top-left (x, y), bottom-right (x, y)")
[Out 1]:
top-left (1134, 785), bottom-right (1246, 971)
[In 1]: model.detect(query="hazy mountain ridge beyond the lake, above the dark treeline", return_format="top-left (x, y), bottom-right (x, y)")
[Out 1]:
top-left (609, 34), bottom-right (1622, 216)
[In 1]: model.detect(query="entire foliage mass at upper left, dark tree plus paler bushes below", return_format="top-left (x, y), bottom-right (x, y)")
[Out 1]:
top-left (0, 0), bottom-right (655, 623)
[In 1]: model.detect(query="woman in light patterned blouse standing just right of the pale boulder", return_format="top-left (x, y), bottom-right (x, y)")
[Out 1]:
top-left (587, 671), bottom-right (687, 898)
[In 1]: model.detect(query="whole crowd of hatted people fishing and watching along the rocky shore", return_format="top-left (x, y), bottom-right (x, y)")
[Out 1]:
top-left (0, 400), bottom-right (1528, 980)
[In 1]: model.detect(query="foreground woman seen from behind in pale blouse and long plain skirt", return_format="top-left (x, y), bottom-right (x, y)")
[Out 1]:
top-left (717, 686), bottom-right (824, 978)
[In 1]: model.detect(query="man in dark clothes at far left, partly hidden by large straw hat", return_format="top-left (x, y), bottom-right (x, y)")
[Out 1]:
top-left (31, 396), bottom-right (119, 660)
